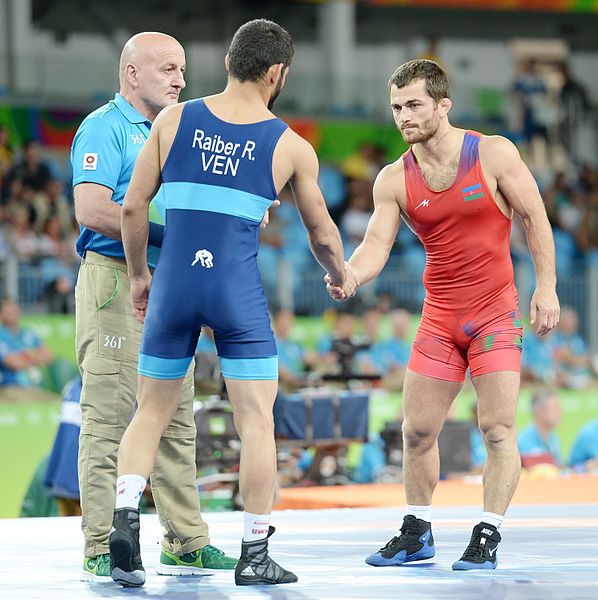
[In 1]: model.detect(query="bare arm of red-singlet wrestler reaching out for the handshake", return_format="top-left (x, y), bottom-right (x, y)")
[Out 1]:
top-left (349, 165), bottom-right (401, 285)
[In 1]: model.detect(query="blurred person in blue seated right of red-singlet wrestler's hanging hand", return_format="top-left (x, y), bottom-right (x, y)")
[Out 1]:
top-left (551, 306), bottom-right (591, 389)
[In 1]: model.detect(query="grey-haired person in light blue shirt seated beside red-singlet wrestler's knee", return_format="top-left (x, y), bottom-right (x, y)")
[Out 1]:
top-left (517, 390), bottom-right (562, 467)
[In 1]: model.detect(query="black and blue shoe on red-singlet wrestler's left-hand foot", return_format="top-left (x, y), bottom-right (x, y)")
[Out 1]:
top-left (365, 515), bottom-right (436, 567)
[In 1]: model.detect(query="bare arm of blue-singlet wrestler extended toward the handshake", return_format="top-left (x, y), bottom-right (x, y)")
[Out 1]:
top-left (293, 134), bottom-right (345, 284)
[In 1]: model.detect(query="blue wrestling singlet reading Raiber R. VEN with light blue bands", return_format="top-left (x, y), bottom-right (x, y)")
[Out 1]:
top-left (139, 99), bottom-right (287, 379)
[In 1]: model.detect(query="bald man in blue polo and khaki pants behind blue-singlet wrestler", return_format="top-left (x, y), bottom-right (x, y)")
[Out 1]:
top-left (71, 33), bottom-right (237, 581)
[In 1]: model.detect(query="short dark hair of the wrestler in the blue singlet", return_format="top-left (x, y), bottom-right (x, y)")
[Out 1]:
top-left (228, 19), bottom-right (294, 81)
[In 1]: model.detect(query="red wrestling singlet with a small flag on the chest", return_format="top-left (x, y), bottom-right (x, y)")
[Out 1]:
top-left (403, 131), bottom-right (522, 382)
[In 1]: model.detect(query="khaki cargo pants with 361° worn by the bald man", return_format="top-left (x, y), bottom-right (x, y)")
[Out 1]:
top-left (75, 252), bottom-right (209, 556)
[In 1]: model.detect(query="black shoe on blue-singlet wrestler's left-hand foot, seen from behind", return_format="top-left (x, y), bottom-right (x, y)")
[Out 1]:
top-left (109, 508), bottom-right (145, 587)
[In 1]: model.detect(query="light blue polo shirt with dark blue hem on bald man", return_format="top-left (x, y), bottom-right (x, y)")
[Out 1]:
top-left (71, 94), bottom-right (164, 267)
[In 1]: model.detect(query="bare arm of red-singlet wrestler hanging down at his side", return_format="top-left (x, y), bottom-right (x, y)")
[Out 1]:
top-left (485, 137), bottom-right (560, 335)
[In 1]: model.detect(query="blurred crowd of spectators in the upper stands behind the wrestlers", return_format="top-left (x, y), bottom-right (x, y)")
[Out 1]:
top-left (0, 55), bottom-right (598, 316)
